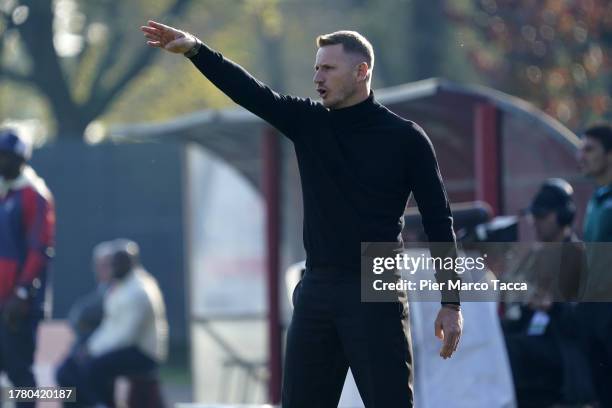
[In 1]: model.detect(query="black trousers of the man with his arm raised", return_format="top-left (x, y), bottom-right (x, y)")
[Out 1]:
top-left (282, 269), bottom-right (413, 408)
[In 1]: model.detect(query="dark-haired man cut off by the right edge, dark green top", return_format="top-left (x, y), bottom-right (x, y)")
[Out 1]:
top-left (578, 124), bottom-right (612, 407)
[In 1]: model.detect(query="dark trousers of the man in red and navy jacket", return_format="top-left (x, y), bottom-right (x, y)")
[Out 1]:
top-left (0, 313), bottom-right (38, 408)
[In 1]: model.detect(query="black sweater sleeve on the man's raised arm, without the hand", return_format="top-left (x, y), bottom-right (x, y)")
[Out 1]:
top-left (191, 44), bottom-right (315, 140)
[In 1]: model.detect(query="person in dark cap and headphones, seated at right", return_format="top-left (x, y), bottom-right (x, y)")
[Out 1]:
top-left (502, 179), bottom-right (592, 408)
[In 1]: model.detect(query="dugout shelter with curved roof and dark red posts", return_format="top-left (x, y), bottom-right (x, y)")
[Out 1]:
top-left (112, 79), bottom-right (591, 402)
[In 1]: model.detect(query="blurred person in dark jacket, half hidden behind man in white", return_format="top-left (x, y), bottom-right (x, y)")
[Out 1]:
top-left (56, 241), bottom-right (113, 406)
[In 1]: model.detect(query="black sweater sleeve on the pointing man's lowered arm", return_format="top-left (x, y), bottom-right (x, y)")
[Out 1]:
top-left (409, 124), bottom-right (459, 303)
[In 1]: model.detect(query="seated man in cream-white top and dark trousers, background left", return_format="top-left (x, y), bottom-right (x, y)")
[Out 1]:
top-left (81, 239), bottom-right (168, 407)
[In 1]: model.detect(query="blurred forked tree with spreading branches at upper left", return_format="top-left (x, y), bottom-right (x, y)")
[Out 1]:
top-left (0, 0), bottom-right (190, 139)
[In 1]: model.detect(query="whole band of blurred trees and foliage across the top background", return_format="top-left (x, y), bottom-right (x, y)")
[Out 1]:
top-left (0, 0), bottom-right (612, 138)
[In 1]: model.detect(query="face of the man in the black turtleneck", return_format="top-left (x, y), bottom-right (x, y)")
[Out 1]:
top-left (312, 44), bottom-right (368, 109)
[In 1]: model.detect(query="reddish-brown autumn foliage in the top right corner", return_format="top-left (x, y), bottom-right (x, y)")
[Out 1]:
top-left (447, 0), bottom-right (612, 129)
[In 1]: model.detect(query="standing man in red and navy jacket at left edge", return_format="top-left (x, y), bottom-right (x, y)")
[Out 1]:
top-left (0, 129), bottom-right (55, 408)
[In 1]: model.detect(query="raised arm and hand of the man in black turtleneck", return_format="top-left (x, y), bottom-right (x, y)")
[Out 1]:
top-left (141, 21), bottom-right (311, 137)
